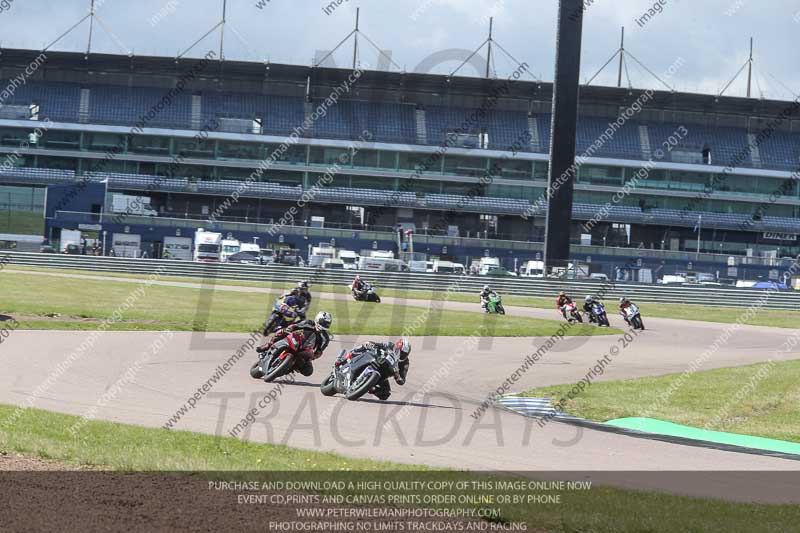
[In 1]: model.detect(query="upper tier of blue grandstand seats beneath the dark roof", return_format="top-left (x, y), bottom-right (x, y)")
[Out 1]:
top-left (0, 80), bottom-right (800, 175)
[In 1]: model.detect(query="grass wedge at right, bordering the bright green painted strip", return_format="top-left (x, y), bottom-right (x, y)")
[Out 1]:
top-left (522, 360), bottom-right (800, 442)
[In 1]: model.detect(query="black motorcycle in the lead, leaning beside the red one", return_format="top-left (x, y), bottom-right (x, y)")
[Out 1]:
top-left (319, 344), bottom-right (399, 400)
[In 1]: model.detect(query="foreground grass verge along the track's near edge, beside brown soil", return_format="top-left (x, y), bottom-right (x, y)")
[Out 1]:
top-left (0, 405), bottom-right (800, 533)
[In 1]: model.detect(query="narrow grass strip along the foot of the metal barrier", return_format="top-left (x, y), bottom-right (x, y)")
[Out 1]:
top-left (9, 265), bottom-right (800, 328)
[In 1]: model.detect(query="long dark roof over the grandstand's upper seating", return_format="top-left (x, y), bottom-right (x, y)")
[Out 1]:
top-left (0, 49), bottom-right (798, 124)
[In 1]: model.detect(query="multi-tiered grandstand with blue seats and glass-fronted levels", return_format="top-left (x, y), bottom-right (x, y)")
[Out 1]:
top-left (0, 46), bottom-right (800, 274)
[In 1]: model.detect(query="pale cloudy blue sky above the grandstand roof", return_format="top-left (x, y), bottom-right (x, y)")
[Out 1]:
top-left (0, 0), bottom-right (800, 99)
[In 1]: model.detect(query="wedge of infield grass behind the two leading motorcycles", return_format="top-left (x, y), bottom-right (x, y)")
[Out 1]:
top-left (0, 272), bottom-right (619, 337)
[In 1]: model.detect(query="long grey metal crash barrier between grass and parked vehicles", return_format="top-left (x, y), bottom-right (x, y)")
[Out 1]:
top-left (6, 251), bottom-right (800, 310)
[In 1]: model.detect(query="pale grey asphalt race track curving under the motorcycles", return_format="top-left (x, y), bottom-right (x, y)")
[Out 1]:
top-left (0, 272), bottom-right (800, 503)
